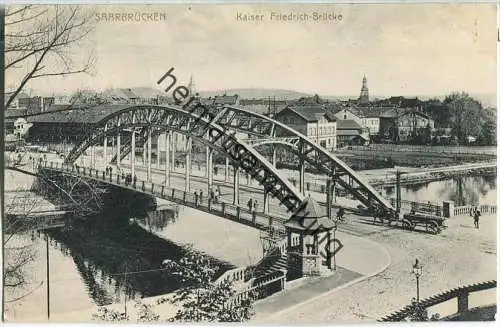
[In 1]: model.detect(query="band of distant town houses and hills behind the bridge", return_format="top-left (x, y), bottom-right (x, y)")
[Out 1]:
top-left (6, 76), bottom-right (444, 151)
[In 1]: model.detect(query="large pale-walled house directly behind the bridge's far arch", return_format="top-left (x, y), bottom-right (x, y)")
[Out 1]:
top-left (274, 102), bottom-right (337, 150)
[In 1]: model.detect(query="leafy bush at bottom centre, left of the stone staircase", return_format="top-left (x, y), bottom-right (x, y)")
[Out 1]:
top-left (163, 247), bottom-right (253, 322)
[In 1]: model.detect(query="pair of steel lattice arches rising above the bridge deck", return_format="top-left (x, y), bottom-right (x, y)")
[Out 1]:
top-left (65, 105), bottom-right (395, 215)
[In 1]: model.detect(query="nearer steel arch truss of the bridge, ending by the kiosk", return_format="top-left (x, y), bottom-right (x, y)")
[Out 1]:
top-left (65, 105), bottom-right (305, 211)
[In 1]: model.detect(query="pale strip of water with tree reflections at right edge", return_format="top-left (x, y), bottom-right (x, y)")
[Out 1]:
top-left (384, 176), bottom-right (497, 206)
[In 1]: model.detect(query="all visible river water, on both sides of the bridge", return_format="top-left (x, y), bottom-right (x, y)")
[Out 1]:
top-left (3, 176), bottom-right (496, 320)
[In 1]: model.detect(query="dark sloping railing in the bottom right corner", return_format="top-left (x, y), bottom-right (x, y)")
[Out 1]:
top-left (378, 280), bottom-right (497, 322)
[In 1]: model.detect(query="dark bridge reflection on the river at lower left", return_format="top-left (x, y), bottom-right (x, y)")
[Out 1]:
top-left (47, 209), bottom-right (232, 305)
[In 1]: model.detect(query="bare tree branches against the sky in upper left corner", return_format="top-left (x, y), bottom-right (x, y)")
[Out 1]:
top-left (5, 5), bottom-right (94, 107)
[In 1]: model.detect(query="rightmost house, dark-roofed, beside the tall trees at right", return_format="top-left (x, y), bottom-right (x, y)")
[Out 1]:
top-left (380, 108), bottom-right (434, 144)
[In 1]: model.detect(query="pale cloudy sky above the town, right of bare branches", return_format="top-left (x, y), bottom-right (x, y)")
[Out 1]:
top-left (6, 4), bottom-right (497, 95)
